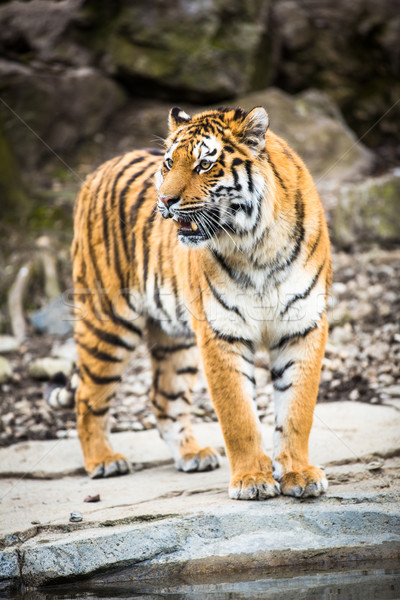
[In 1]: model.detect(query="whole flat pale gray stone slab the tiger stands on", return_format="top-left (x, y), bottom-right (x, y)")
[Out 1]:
top-left (0, 402), bottom-right (400, 585)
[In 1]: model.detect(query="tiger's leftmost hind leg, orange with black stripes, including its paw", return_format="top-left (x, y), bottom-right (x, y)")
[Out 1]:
top-left (75, 315), bottom-right (145, 478)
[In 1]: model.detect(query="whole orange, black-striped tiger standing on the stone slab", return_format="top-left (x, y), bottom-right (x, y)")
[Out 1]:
top-left (72, 108), bottom-right (331, 500)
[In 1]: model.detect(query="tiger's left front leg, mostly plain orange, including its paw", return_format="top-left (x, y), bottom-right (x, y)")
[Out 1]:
top-left (196, 322), bottom-right (280, 500)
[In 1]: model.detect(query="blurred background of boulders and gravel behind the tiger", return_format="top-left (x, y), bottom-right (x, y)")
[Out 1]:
top-left (0, 0), bottom-right (400, 445)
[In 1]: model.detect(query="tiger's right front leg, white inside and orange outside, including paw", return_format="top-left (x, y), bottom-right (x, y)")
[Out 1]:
top-left (270, 316), bottom-right (328, 498)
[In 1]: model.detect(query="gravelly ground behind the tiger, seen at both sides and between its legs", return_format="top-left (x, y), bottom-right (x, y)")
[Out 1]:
top-left (0, 248), bottom-right (400, 446)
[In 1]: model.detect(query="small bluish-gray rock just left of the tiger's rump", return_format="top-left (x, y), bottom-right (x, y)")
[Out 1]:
top-left (31, 295), bottom-right (73, 336)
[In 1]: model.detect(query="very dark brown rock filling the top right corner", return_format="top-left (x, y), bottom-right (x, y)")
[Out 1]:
top-left (273, 0), bottom-right (400, 150)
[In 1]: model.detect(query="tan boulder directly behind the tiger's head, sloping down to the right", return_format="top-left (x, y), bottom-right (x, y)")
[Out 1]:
top-left (233, 88), bottom-right (373, 183)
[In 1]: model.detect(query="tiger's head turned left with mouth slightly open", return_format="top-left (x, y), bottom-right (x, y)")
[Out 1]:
top-left (156, 107), bottom-right (268, 247)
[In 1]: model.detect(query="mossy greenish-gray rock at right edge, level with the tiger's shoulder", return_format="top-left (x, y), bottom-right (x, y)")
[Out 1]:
top-left (330, 170), bottom-right (400, 247)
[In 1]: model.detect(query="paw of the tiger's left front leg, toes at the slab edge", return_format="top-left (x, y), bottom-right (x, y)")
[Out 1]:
top-left (229, 471), bottom-right (281, 500)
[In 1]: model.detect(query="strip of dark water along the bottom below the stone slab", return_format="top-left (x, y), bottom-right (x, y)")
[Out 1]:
top-left (7, 561), bottom-right (400, 600)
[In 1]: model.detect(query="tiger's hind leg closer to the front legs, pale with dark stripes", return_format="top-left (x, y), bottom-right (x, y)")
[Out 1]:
top-left (148, 324), bottom-right (219, 472)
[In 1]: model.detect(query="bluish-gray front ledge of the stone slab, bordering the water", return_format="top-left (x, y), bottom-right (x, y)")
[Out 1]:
top-left (3, 499), bottom-right (400, 585)
